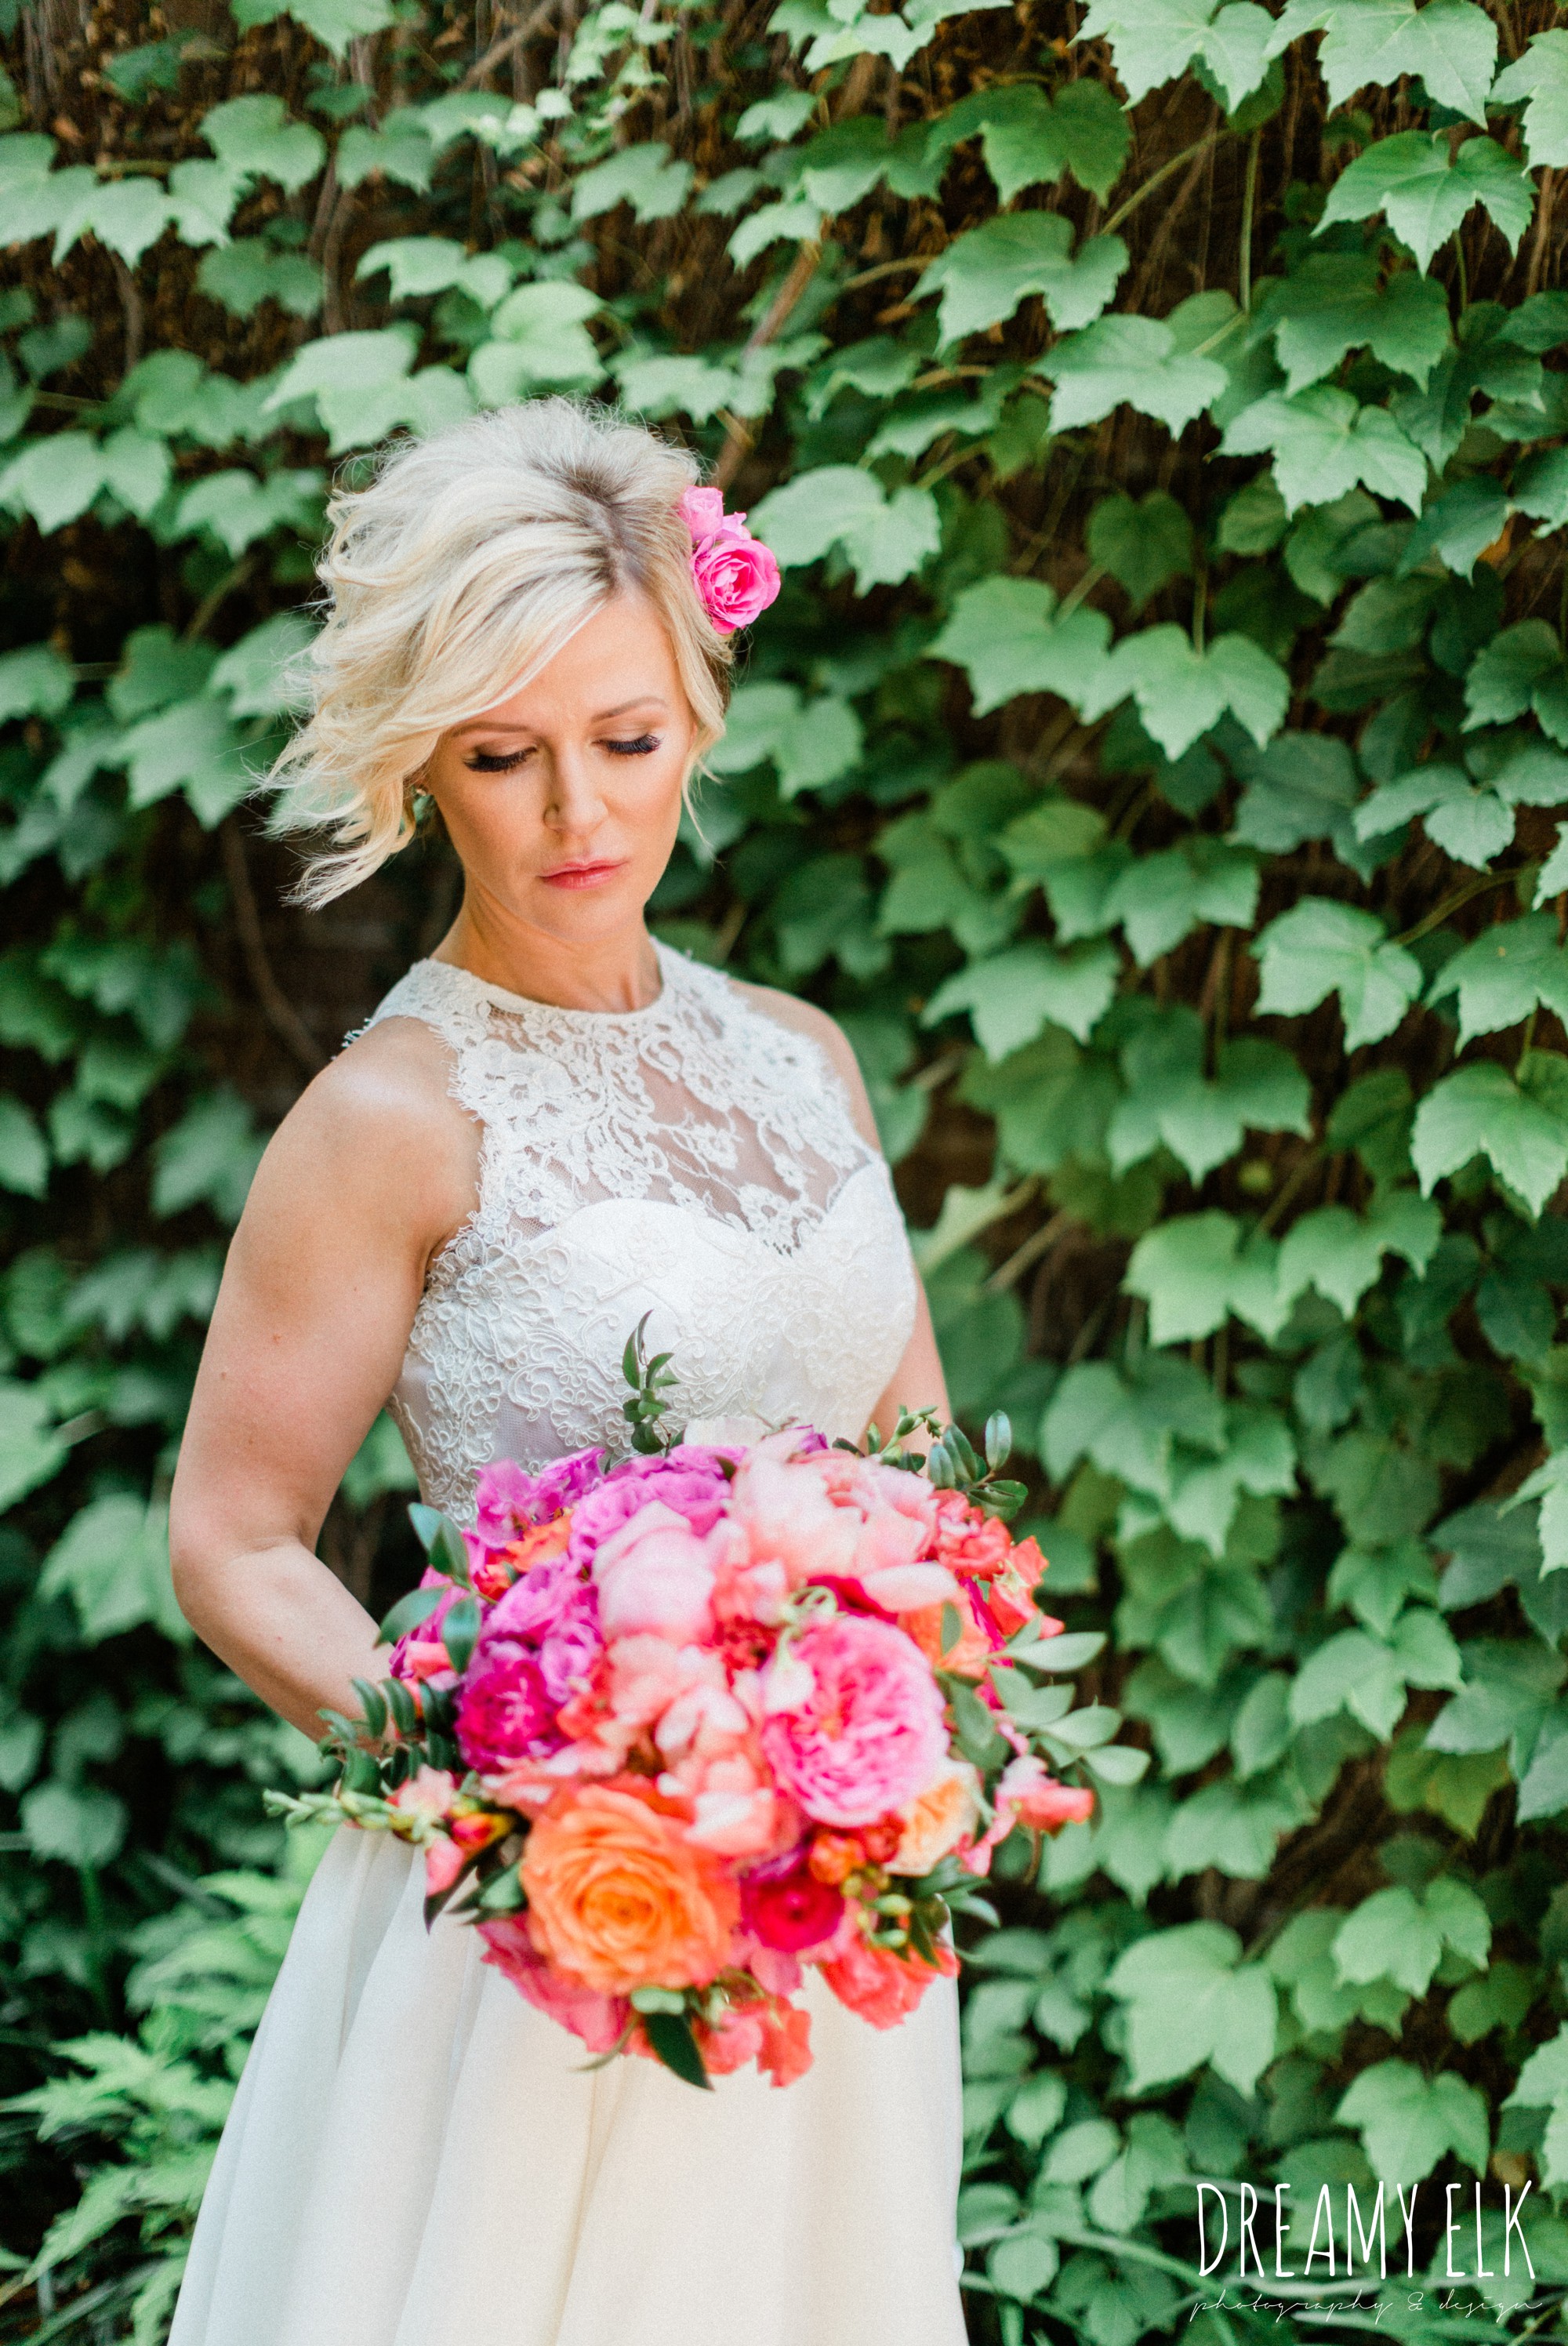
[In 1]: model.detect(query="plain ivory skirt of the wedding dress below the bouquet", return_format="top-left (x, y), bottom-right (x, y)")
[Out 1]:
top-left (169, 1828), bottom-right (981, 2346)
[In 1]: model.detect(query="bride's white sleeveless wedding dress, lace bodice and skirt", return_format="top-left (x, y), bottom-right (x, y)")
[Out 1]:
top-left (172, 948), bottom-right (965, 2346)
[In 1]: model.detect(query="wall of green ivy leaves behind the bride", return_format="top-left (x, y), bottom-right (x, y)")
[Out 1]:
top-left (0, 0), bottom-right (1568, 2346)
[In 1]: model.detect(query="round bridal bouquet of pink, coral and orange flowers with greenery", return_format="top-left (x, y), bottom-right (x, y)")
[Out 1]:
top-left (274, 1330), bottom-right (1112, 2086)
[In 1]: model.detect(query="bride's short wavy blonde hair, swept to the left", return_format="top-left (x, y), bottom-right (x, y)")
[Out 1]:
top-left (272, 399), bottom-right (730, 906)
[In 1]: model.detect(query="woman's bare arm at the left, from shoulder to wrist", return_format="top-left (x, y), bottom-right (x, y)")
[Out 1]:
top-left (169, 1019), bottom-right (479, 1741)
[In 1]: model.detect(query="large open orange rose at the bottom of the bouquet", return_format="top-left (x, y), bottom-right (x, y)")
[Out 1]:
top-left (524, 1783), bottom-right (739, 1996)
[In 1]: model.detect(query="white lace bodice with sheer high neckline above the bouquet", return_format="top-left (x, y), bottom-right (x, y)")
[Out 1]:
top-left (371, 946), bottom-right (918, 1523)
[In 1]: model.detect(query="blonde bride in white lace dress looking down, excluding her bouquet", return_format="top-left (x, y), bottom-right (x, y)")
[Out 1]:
top-left (172, 399), bottom-right (965, 2346)
